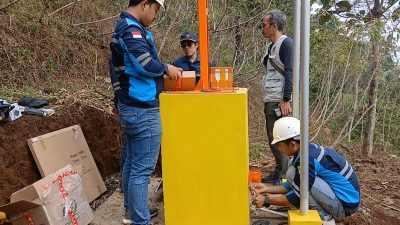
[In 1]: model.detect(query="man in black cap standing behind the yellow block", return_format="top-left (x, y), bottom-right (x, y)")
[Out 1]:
top-left (172, 31), bottom-right (213, 84)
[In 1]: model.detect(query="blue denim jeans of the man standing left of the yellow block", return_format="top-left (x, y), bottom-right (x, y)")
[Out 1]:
top-left (118, 102), bottom-right (161, 225)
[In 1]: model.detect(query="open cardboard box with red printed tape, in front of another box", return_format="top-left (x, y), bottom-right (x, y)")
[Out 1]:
top-left (6, 165), bottom-right (93, 225)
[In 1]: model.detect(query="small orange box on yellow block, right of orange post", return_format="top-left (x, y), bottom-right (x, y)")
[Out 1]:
top-left (210, 67), bottom-right (233, 89)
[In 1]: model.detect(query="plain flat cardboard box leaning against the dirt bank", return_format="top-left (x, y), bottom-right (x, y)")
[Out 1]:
top-left (28, 125), bottom-right (106, 202)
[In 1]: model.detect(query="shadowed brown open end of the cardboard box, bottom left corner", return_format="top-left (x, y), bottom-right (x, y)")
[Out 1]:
top-left (0, 200), bottom-right (50, 225)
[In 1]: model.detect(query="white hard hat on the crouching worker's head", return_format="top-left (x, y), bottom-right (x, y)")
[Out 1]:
top-left (271, 117), bottom-right (300, 145)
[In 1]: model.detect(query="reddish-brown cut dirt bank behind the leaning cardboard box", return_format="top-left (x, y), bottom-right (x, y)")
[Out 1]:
top-left (0, 104), bottom-right (121, 204)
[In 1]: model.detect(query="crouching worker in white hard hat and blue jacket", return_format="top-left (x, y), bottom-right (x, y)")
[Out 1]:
top-left (250, 117), bottom-right (360, 224)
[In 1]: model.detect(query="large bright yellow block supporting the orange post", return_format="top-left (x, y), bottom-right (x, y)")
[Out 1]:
top-left (160, 89), bottom-right (250, 225)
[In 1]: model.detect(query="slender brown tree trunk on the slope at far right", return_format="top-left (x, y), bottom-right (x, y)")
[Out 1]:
top-left (363, 39), bottom-right (381, 157)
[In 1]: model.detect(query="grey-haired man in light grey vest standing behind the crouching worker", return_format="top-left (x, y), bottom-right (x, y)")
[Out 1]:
top-left (260, 10), bottom-right (293, 184)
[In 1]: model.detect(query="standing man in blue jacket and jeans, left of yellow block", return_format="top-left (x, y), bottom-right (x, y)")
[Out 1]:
top-left (110, 0), bottom-right (182, 225)
